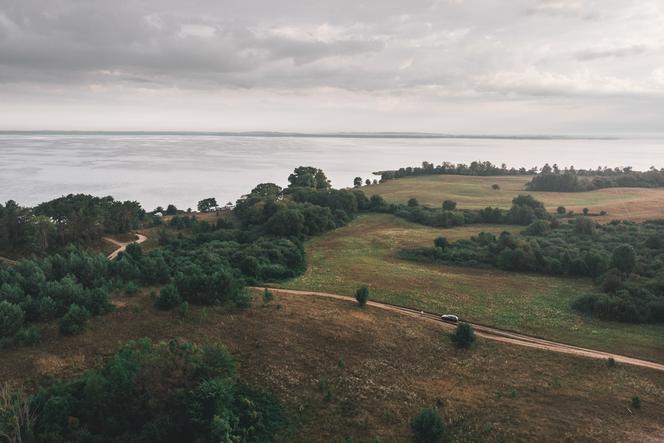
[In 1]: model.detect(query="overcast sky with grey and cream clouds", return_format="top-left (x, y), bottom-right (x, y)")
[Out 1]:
top-left (0, 0), bottom-right (664, 135)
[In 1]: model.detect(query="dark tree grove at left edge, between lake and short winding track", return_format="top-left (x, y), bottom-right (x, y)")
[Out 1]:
top-left (0, 194), bottom-right (145, 255)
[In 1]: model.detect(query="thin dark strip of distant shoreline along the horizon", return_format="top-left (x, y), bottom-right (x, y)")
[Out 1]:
top-left (0, 130), bottom-right (664, 140)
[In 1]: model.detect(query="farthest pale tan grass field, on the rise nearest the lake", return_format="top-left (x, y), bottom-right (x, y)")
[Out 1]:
top-left (362, 175), bottom-right (664, 221)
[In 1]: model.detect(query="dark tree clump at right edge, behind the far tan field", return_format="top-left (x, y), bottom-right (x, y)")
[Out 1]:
top-left (526, 168), bottom-right (664, 192)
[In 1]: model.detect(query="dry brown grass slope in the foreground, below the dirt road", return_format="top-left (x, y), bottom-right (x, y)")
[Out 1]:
top-left (0, 293), bottom-right (664, 442)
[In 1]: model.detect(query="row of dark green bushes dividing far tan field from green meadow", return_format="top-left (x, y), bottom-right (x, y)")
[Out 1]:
top-left (368, 195), bottom-right (551, 228)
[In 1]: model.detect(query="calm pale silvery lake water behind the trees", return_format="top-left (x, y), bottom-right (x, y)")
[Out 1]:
top-left (0, 133), bottom-right (664, 209)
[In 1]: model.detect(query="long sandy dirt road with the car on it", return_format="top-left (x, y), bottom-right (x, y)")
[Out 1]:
top-left (253, 288), bottom-right (664, 371)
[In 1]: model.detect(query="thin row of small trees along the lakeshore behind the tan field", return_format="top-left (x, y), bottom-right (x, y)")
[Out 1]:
top-left (380, 161), bottom-right (538, 181)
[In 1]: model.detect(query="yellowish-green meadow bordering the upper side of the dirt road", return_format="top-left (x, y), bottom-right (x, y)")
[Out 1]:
top-left (283, 215), bottom-right (664, 362)
